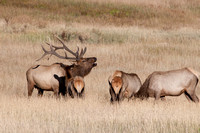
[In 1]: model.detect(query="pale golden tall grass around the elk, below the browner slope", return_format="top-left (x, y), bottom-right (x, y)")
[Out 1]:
top-left (0, 24), bottom-right (200, 133)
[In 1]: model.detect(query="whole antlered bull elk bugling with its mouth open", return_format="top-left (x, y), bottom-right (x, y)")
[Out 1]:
top-left (26, 37), bottom-right (97, 96)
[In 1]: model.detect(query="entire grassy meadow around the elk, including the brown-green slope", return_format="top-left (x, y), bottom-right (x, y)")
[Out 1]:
top-left (0, 0), bottom-right (200, 133)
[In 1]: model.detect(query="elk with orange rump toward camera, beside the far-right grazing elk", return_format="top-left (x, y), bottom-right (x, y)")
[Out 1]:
top-left (108, 71), bottom-right (141, 102)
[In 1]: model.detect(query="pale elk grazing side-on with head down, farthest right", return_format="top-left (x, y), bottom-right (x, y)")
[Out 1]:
top-left (135, 68), bottom-right (199, 102)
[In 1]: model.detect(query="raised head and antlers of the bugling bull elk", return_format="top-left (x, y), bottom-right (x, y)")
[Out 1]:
top-left (37, 37), bottom-right (97, 77)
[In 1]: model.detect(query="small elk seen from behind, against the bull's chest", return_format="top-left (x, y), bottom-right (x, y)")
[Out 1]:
top-left (67, 76), bottom-right (85, 98)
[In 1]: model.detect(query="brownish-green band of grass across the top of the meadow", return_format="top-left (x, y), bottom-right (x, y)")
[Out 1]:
top-left (0, 0), bottom-right (199, 28)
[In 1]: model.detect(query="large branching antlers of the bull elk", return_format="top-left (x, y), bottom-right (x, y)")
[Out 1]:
top-left (36, 36), bottom-right (87, 61)
